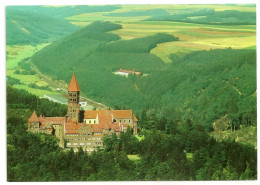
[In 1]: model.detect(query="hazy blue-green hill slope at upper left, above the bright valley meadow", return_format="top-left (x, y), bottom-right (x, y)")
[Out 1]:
top-left (6, 8), bottom-right (78, 45)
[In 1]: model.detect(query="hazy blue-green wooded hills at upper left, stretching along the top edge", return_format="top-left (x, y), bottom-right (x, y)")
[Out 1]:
top-left (6, 5), bottom-right (119, 45)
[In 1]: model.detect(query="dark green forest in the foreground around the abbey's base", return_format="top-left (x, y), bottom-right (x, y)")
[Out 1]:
top-left (7, 86), bottom-right (257, 181)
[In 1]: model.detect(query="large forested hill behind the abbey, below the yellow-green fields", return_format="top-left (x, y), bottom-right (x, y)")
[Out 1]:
top-left (32, 22), bottom-right (256, 129)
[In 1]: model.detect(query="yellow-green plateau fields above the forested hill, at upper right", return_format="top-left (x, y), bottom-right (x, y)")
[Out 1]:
top-left (67, 5), bottom-right (256, 63)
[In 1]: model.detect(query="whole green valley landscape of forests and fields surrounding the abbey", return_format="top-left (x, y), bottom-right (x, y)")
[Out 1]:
top-left (6, 4), bottom-right (257, 181)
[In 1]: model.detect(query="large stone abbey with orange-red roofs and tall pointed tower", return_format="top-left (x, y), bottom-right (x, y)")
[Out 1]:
top-left (28, 74), bottom-right (138, 152)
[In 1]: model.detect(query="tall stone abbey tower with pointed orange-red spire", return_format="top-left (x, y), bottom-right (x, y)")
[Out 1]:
top-left (67, 73), bottom-right (80, 123)
